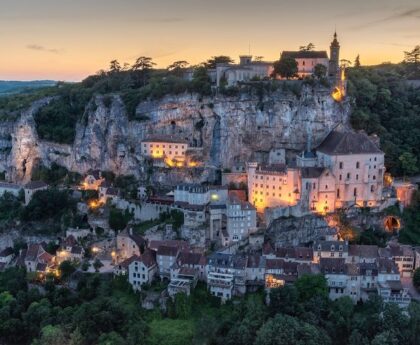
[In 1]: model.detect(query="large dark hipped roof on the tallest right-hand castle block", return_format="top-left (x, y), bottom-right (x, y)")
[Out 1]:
top-left (317, 131), bottom-right (383, 155)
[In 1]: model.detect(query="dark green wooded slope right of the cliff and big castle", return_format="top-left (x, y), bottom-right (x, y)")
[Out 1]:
top-left (348, 64), bottom-right (420, 176)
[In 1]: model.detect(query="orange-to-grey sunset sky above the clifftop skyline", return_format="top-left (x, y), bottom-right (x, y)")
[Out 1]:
top-left (0, 0), bottom-right (420, 81)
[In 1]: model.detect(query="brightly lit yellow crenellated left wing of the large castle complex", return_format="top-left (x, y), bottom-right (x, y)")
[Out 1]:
top-left (248, 163), bottom-right (301, 212)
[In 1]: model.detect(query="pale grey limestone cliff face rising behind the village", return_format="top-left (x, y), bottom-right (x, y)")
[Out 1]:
top-left (0, 87), bottom-right (349, 182)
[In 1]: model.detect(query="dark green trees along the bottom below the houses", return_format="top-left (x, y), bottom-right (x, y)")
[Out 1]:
top-left (0, 268), bottom-right (420, 345)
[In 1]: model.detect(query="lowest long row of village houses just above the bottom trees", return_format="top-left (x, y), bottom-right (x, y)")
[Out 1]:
top-left (110, 226), bottom-right (420, 307)
